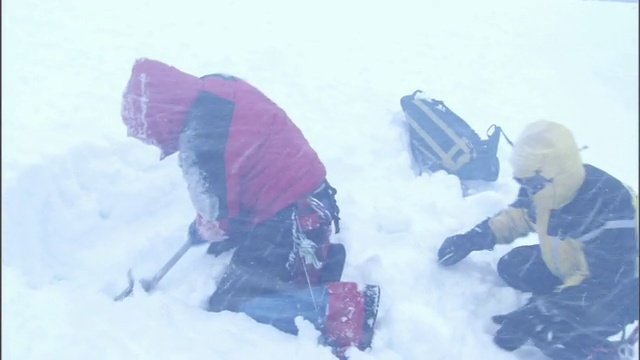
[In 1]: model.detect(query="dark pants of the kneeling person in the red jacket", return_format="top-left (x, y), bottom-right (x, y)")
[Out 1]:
top-left (209, 183), bottom-right (345, 312)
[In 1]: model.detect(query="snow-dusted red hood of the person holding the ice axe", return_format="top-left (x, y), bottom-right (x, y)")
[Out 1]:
top-left (122, 58), bottom-right (202, 160)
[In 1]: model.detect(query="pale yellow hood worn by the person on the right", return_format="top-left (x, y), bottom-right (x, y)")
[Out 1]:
top-left (510, 120), bottom-right (585, 211)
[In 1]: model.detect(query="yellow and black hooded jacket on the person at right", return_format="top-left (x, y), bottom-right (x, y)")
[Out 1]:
top-left (489, 121), bottom-right (638, 287)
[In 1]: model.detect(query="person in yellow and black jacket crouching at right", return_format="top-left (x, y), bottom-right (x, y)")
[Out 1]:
top-left (438, 120), bottom-right (639, 359)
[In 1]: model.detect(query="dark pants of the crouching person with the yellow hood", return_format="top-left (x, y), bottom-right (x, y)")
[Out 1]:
top-left (497, 245), bottom-right (638, 359)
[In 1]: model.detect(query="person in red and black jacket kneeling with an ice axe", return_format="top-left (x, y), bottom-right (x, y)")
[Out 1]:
top-left (122, 58), bottom-right (379, 356)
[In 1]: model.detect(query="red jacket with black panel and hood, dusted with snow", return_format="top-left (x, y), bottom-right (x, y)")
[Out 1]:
top-left (122, 59), bottom-right (326, 239)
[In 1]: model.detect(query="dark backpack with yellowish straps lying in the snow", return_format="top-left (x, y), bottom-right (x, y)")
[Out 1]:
top-left (400, 90), bottom-right (511, 181)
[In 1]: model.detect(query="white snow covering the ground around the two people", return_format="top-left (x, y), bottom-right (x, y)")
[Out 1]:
top-left (2, 0), bottom-right (638, 360)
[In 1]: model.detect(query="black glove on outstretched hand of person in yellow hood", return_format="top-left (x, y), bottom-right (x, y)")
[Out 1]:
top-left (438, 219), bottom-right (496, 266)
